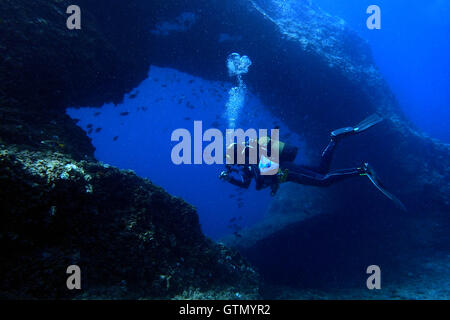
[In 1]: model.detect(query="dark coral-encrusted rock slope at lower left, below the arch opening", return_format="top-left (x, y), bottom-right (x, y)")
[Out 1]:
top-left (0, 145), bottom-right (258, 299)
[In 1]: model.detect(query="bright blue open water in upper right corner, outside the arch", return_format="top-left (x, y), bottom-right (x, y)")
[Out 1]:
top-left (314, 0), bottom-right (450, 142)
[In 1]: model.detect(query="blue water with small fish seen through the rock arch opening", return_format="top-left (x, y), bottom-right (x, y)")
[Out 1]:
top-left (68, 67), bottom-right (302, 239)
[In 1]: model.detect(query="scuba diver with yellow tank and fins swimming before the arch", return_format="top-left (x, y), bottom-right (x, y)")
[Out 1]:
top-left (219, 114), bottom-right (406, 211)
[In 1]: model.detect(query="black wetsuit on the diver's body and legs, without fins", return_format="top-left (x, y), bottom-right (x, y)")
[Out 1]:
top-left (228, 139), bottom-right (361, 191)
